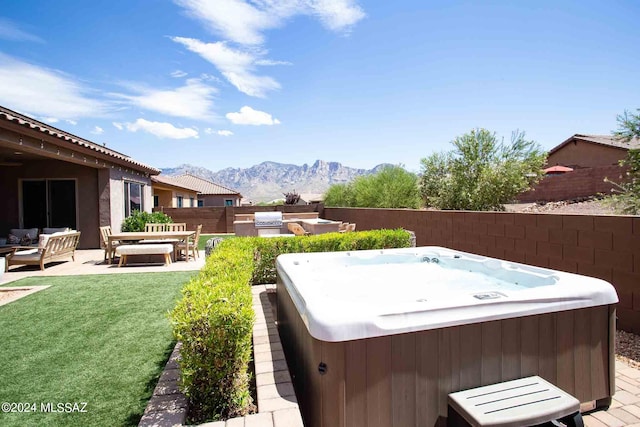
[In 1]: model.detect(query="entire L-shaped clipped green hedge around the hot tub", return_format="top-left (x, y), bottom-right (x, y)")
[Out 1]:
top-left (170, 230), bottom-right (411, 422)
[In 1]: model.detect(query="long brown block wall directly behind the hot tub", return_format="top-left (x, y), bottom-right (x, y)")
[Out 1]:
top-left (323, 208), bottom-right (640, 333)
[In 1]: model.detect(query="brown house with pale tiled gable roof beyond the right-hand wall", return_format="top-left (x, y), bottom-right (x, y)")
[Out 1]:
top-left (547, 134), bottom-right (640, 169)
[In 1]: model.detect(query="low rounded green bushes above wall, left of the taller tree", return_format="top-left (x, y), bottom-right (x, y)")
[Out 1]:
top-left (324, 166), bottom-right (420, 209)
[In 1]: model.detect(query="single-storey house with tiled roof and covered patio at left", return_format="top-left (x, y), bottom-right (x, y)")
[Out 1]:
top-left (0, 107), bottom-right (160, 248)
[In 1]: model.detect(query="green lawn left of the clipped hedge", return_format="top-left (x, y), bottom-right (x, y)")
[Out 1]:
top-left (0, 272), bottom-right (195, 426)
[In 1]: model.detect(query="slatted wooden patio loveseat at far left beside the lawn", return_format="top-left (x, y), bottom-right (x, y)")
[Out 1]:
top-left (5, 231), bottom-right (80, 271)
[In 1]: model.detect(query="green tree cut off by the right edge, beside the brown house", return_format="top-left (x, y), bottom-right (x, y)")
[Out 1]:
top-left (605, 109), bottom-right (640, 215)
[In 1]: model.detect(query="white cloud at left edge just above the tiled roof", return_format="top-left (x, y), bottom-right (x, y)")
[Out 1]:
top-left (0, 53), bottom-right (108, 120)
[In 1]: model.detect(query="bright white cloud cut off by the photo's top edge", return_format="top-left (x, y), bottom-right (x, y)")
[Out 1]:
top-left (176, 0), bottom-right (365, 45)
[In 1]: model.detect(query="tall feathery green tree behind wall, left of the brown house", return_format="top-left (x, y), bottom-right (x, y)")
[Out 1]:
top-left (420, 129), bottom-right (546, 211)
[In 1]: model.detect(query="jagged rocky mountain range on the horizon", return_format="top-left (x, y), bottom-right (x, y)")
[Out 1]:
top-left (162, 160), bottom-right (388, 202)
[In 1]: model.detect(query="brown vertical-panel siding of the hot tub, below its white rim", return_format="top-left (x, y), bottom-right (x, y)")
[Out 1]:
top-left (277, 278), bottom-right (615, 427)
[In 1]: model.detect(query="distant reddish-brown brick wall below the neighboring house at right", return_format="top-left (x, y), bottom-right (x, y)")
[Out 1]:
top-left (518, 166), bottom-right (624, 202)
